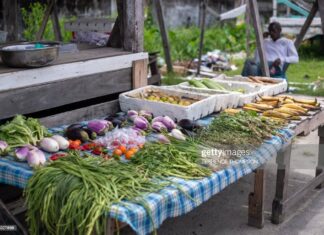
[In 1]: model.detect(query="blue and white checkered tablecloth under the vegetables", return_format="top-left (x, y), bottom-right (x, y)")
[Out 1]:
top-left (0, 120), bottom-right (293, 234)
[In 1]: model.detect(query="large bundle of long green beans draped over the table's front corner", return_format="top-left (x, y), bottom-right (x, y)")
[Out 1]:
top-left (25, 152), bottom-right (166, 235)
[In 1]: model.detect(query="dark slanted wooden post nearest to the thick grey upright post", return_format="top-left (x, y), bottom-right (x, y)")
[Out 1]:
top-left (153, 0), bottom-right (173, 72)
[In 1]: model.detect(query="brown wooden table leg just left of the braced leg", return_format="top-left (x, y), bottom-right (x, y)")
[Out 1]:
top-left (248, 168), bottom-right (265, 228)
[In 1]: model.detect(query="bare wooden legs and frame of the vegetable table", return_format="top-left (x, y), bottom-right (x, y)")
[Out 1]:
top-left (248, 95), bottom-right (324, 228)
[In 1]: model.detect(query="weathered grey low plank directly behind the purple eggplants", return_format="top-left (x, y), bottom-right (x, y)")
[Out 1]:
top-left (40, 100), bottom-right (120, 127)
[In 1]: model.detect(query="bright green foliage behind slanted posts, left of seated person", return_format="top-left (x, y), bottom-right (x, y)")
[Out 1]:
top-left (144, 21), bottom-right (253, 61)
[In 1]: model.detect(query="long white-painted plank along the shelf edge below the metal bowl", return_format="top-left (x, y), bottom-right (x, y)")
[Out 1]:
top-left (0, 53), bottom-right (147, 94)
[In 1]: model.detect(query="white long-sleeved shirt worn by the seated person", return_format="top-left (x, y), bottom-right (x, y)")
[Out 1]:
top-left (255, 38), bottom-right (299, 66)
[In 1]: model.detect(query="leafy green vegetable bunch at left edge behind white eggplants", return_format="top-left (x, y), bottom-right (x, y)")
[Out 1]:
top-left (0, 115), bottom-right (49, 148)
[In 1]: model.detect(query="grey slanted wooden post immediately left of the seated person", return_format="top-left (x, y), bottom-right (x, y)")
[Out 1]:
top-left (249, 0), bottom-right (270, 77)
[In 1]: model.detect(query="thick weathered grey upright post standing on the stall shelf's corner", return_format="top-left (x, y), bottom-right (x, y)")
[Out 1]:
top-left (123, 0), bottom-right (144, 52)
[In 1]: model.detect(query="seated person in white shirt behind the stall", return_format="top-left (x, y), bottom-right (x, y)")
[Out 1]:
top-left (242, 22), bottom-right (299, 79)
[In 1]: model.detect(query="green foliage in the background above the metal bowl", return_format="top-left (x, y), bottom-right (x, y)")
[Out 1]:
top-left (21, 2), bottom-right (72, 42)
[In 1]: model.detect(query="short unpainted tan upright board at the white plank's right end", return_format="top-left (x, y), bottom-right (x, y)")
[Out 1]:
top-left (132, 60), bottom-right (147, 89)
